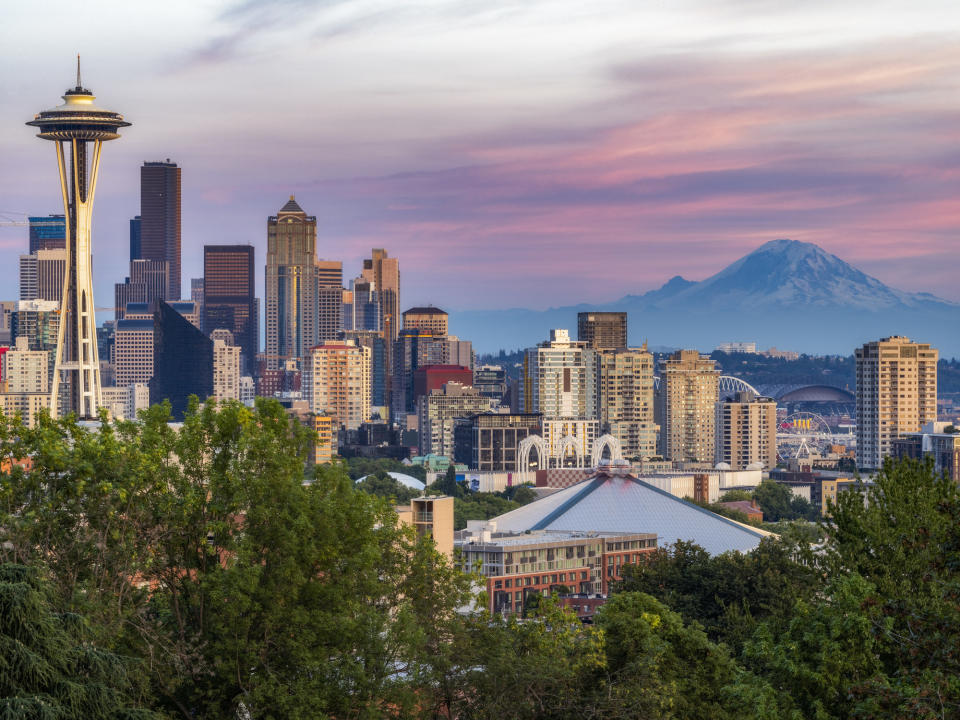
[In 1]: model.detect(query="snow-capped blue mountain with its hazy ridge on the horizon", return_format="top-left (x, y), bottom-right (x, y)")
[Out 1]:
top-left (450, 239), bottom-right (960, 357)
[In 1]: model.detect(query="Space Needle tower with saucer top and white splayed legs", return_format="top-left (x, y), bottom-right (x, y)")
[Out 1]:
top-left (27, 64), bottom-right (130, 419)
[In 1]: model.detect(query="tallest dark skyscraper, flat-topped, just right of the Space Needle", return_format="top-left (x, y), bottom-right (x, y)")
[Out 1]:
top-left (140, 159), bottom-right (180, 300)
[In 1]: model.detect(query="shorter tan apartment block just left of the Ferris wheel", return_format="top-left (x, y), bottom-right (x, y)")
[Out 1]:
top-left (713, 392), bottom-right (777, 470)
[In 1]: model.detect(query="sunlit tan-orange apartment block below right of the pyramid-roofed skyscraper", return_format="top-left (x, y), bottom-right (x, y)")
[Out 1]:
top-left (301, 340), bottom-right (371, 430)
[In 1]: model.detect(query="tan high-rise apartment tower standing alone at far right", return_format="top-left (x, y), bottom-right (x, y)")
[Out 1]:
top-left (855, 336), bottom-right (939, 468)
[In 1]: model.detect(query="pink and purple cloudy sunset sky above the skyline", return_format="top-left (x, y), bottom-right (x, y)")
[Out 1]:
top-left (0, 0), bottom-right (960, 312)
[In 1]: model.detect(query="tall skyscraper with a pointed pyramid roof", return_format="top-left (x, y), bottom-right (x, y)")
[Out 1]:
top-left (266, 195), bottom-right (317, 370)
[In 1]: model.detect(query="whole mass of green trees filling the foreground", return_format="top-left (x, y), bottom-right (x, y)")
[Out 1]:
top-left (0, 399), bottom-right (960, 720)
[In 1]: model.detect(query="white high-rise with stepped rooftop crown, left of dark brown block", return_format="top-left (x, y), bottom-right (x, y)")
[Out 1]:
top-left (521, 329), bottom-right (596, 420)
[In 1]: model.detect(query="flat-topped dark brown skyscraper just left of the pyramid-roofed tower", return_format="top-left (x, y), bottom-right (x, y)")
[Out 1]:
top-left (203, 245), bottom-right (260, 375)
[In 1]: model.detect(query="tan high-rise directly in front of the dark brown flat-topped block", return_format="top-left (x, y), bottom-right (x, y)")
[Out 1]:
top-left (596, 347), bottom-right (657, 459)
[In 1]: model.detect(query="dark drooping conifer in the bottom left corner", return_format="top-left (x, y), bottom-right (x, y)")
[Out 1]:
top-left (0, 564), bottom-right (155, 720)
